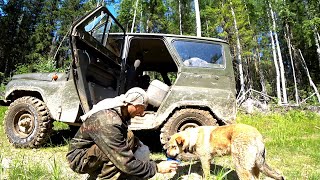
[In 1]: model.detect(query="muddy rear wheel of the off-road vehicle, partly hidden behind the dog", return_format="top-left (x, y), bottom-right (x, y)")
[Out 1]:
top-left (160, 109), bottom-right (218, 160)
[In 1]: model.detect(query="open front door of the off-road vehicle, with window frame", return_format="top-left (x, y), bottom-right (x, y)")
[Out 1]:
top-left (70, 6), bottom-right (125, 113)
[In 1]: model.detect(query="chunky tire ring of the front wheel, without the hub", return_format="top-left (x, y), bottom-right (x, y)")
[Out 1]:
top-left (4, 96), bottom-right (53, 148)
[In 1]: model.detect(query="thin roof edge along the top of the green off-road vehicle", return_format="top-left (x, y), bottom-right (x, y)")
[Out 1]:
top-left (110, 33), bottom-right (228, 43)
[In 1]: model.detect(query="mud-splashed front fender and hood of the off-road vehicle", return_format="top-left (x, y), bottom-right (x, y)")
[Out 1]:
top-left (4, 73), bottom-right (80, 123)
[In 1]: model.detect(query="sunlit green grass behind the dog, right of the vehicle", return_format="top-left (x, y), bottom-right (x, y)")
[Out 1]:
top-left (237, 110), bottom-right (320, 179)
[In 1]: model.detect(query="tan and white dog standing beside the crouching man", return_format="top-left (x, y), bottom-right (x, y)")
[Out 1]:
top-left (166, 124), bottom-right (284, 180)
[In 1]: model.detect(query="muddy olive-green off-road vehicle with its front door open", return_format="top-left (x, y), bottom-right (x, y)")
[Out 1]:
top-left (3, 7), bottom-right (236, 147)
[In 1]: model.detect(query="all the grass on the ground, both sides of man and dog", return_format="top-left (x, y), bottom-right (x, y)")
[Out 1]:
top-left (0, 106), bottom-right (320, 180)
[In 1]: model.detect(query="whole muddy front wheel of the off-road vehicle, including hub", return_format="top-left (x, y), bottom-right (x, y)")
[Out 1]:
top-left (4, 96), bottom-right (52, 148)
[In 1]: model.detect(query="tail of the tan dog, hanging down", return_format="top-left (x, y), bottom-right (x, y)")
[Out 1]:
top-left (256, 143), bottom-right (284, 180)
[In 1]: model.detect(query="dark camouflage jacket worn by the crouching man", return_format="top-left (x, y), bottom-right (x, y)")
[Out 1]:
top-left (67, 108), bottom-right (156, 179)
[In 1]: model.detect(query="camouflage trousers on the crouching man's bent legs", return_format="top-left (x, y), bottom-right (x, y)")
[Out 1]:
top-left (69, 131), bottom-right (139, 180)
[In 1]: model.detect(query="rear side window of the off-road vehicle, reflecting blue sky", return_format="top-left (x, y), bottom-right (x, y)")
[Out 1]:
top-left (172, 40), bottom-right (225, 68)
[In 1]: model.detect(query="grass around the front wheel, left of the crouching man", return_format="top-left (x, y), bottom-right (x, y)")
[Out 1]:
top-left (0, 106), bottom-right (86, 180)
